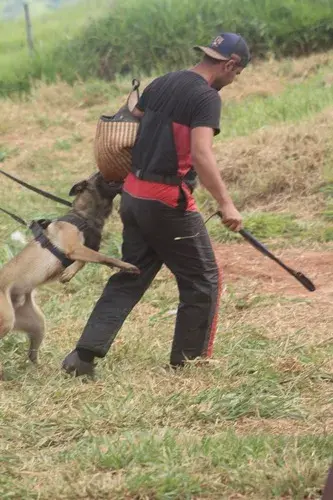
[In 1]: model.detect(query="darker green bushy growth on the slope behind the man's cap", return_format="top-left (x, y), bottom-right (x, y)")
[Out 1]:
top-left (0, 0), bottom-right (333, 94)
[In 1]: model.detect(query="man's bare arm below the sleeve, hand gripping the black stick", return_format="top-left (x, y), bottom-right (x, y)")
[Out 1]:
top-left (191, 127), bottom-right (242, 231)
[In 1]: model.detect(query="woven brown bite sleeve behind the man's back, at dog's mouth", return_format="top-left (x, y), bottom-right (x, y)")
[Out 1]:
top-left (94, 80), bottom-right (140, 182)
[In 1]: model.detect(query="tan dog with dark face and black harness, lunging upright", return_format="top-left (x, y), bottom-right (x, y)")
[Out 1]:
top-left (0, 173), bottom-right (139, 363)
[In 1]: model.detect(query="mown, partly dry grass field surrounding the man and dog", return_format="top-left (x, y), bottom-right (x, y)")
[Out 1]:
top-left (0, 52), bottom-right (333, 500)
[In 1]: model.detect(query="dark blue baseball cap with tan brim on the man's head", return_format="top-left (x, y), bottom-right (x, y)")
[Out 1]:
top-left (193, 33), bottom-right (251, 68)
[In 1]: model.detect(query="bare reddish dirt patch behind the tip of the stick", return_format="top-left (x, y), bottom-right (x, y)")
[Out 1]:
top-left (214, 244), bottom-right (333, 303)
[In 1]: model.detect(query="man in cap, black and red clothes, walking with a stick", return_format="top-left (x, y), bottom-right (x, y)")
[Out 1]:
top-left (63, 33), bottom-right (250, 376)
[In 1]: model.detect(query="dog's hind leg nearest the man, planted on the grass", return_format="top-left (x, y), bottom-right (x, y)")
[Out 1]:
top-left (14, 292), bottom-right (45, 363)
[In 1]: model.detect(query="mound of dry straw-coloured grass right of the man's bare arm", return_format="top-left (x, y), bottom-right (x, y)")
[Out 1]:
top-left (216, 108), bottom-right (333, 211)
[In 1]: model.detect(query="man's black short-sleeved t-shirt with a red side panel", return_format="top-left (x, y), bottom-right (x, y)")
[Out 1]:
top-left (132, 70), bottom-right (221, 181)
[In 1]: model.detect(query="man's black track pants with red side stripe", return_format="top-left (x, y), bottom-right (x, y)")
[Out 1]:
top-left (77, 192), bottom-right (220, 365)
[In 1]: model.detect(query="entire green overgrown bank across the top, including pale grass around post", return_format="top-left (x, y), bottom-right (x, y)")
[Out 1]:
top-left (0, 0), bottom-right (333, 95)
